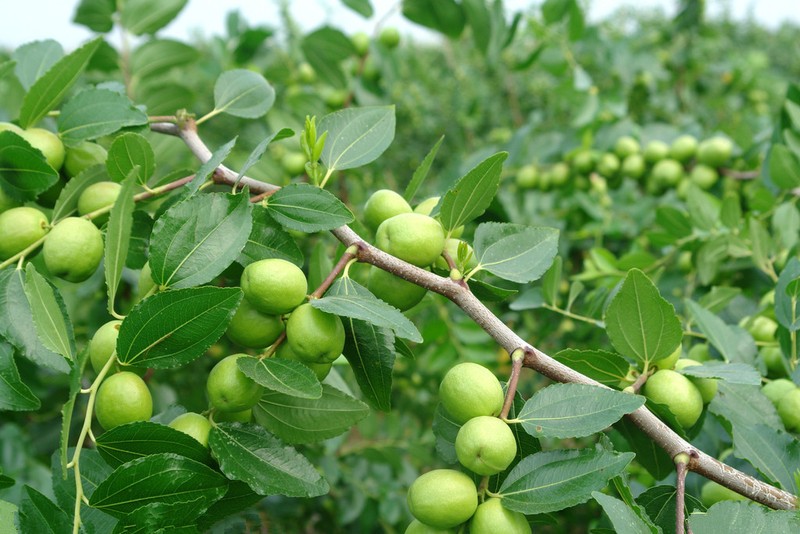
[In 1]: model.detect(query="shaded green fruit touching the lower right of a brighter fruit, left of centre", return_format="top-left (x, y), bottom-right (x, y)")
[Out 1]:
top-left (286, 303), bottom-right (345, 363)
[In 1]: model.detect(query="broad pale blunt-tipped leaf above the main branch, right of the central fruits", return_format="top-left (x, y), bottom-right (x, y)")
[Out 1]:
top-left (473, 223), bottom-right (558, 283)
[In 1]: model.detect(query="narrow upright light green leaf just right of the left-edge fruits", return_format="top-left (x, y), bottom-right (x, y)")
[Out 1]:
top-left (104, 167), bottom-right (139, 315)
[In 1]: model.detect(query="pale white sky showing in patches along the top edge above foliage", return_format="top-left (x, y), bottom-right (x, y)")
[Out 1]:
top-left (0, 0), bottom-right (800, 49)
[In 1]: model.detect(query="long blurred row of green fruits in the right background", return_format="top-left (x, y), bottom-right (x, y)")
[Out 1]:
top-left (516, 134), bottom-right (733, 195)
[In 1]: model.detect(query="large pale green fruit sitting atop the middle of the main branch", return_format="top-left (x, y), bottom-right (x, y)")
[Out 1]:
top-left (375, 213), bottom-right (444, 267)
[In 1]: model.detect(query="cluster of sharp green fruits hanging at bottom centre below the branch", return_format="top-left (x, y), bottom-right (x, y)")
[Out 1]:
top-left (406, 363), bottom-right (531, 534)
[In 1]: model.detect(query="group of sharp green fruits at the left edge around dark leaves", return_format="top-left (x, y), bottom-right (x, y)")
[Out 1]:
top-left (0, 123), bottom-right (120, 282)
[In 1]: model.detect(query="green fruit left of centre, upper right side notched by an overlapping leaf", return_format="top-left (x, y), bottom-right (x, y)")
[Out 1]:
top-left (206, 354), bottom-right (263, 412)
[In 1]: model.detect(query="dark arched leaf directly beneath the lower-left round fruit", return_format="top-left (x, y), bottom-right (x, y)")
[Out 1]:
top-left (96, 421), bottom-right (212, 468)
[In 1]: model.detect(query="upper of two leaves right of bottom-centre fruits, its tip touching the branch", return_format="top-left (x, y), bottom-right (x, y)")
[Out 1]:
top-left (517, 384), bottom-right (645, 438)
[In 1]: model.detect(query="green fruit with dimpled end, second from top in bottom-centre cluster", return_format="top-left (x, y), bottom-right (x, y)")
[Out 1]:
top-left (456, 415), bottom-right (517, 475)
